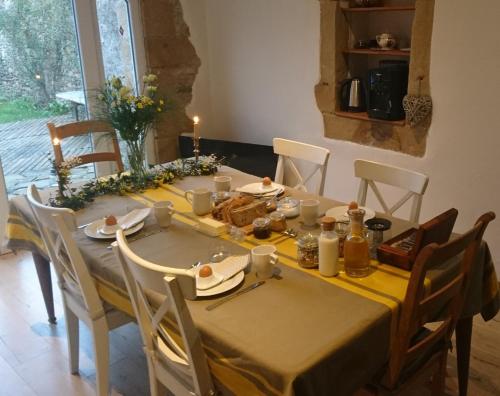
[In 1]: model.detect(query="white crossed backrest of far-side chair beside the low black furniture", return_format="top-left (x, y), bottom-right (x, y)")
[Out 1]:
top-left (273, 138), bottom-right (330, 195)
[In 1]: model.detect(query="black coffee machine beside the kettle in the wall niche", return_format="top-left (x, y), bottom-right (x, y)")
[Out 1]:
top-left (366, 61), bottom-right (409, 121)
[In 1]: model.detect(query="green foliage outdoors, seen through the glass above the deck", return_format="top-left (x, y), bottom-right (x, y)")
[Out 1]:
top-left (0, 0), bottom-right (81, 105)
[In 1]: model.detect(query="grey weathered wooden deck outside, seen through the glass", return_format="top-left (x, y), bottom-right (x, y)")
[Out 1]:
top-left (0, 115), bottom-right (94, 195)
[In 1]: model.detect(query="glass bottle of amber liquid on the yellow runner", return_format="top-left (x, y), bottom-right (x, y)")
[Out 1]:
top-left (344, 209), bottom-right (370, 278)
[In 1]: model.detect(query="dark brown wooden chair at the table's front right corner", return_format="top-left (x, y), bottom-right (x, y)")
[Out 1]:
top-left (371, 212), bottom-right (495, 396)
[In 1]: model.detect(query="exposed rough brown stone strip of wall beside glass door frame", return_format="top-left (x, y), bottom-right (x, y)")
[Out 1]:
top-left (142, 0), bottom-right (201, 163)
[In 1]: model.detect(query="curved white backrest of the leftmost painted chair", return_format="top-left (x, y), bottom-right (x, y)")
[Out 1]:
top-left (27, 184), bottom-right (104, 319)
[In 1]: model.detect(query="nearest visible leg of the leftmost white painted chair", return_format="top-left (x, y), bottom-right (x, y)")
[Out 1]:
top-left (91, 317), bottom-right (109, 396)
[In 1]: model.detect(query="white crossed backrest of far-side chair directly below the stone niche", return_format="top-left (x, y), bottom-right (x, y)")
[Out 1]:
top-left (354, 159), bottom-right (429, 223)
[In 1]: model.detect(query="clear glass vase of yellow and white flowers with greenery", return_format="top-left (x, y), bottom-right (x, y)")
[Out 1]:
top-left (98, 74), bottom-right (164, 183)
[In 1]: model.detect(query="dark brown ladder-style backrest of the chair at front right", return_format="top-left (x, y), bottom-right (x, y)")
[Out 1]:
top-left (386, 212), bottom-right (495, 388)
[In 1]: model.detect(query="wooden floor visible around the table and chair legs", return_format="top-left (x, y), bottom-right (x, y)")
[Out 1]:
top-left (0, 253), bottom-right (500, 396)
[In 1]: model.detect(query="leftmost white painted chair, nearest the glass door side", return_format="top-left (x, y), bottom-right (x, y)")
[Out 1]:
top-left (28, 184), bottom-right (133, 396)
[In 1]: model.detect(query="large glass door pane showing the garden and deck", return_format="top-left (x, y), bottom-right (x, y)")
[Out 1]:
top-left (0, 0), bottom-right (95, 194)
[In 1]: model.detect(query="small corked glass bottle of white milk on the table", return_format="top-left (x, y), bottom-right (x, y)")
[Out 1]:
top-left (318, 216), bottom-right (339, 276)
